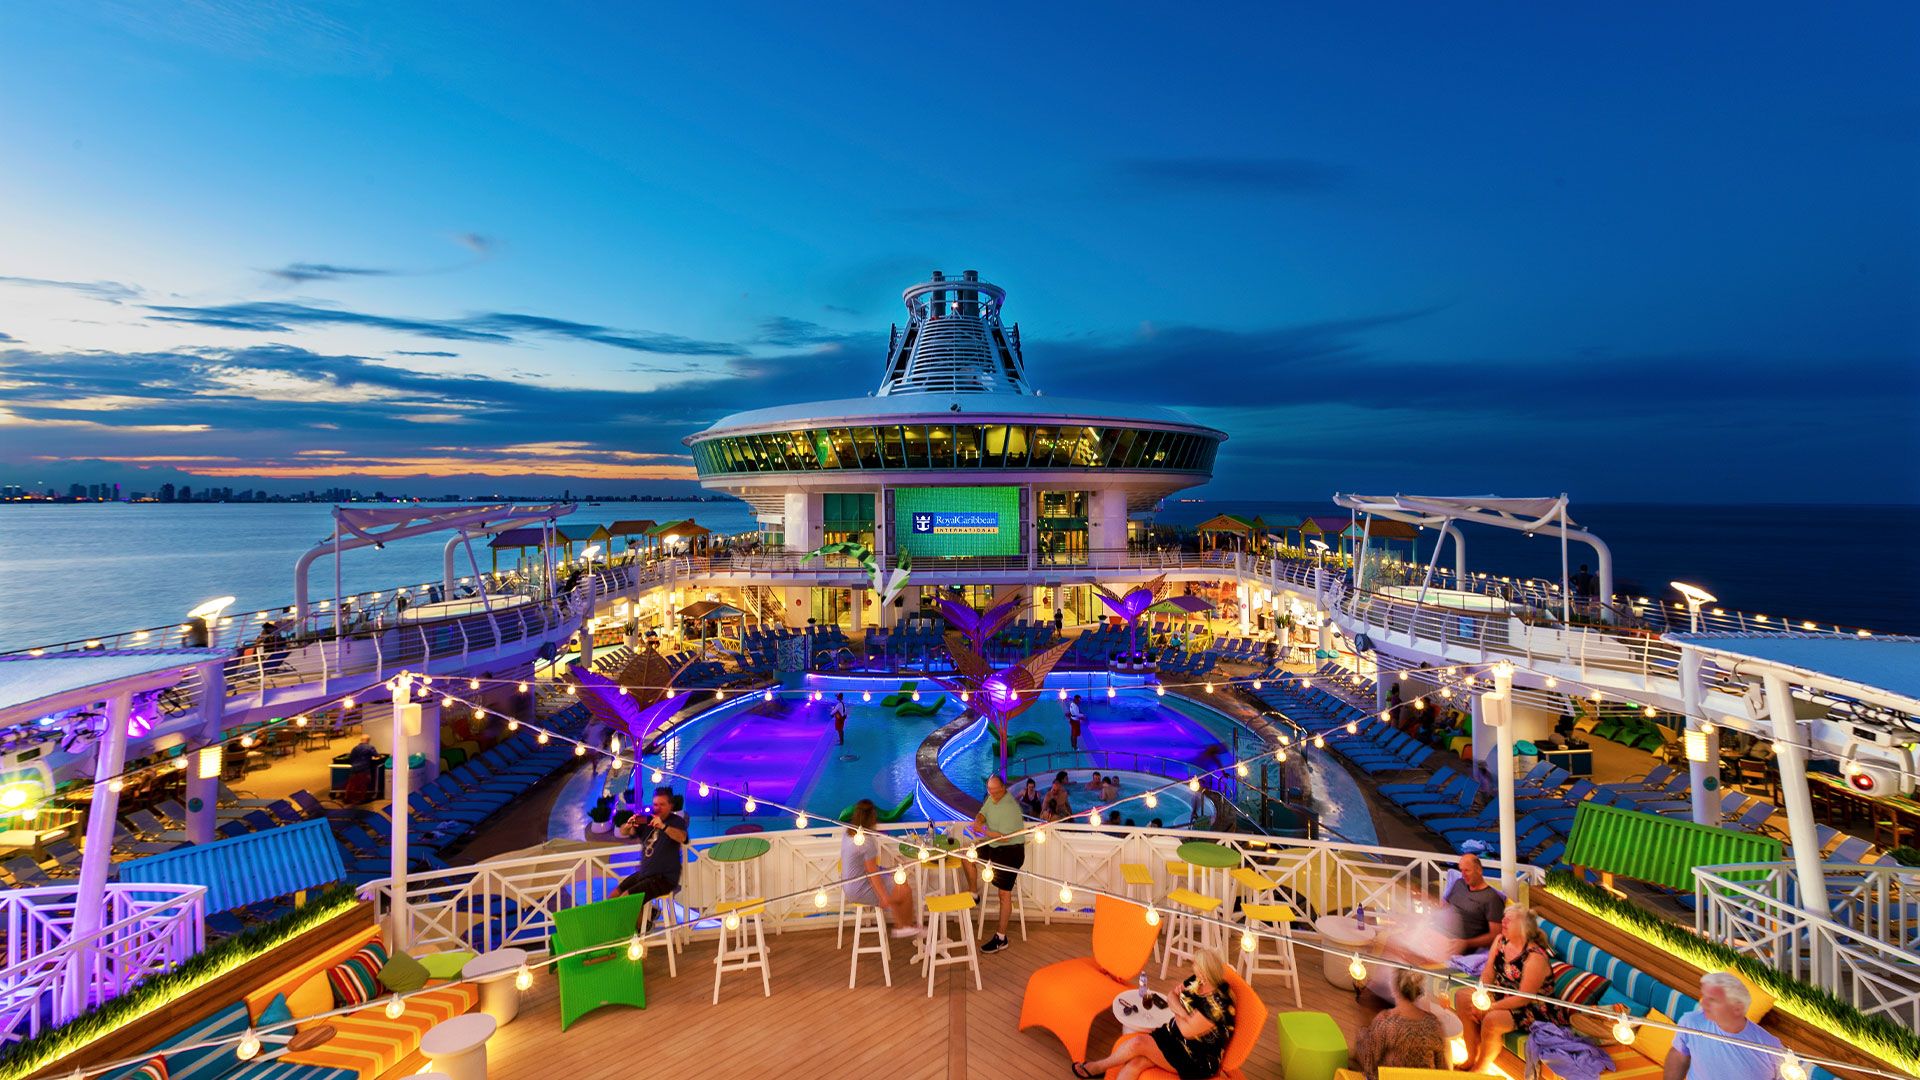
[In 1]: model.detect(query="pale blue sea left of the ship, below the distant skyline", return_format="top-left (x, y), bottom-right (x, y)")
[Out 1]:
top-left (0, 500), bottom-right (755, 651)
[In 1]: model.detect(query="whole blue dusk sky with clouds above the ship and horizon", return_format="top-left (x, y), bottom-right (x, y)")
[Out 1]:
top-left (0, 0), bottom-right (1920, 502)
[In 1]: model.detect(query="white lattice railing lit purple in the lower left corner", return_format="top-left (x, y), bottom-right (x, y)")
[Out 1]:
top-left (0, 884), bottom-right (207, 1045)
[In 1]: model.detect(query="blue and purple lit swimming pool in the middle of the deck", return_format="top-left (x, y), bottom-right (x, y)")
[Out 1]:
top-left (553, 673), bottom-right (1373, 838)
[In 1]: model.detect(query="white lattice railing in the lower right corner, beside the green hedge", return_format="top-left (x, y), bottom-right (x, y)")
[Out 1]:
top-left (1693, 863), bottom-right (1920, 1030)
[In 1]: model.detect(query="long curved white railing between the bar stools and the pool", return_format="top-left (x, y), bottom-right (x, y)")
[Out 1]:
top-left (361, 822), bottom-right (1538, 953)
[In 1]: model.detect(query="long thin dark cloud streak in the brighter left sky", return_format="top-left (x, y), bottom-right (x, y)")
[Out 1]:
top-left (146, 300), bottom-right (741, 356)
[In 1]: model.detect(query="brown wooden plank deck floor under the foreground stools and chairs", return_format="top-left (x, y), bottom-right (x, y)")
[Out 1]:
top-left (490, 920), bottom-right (1373, 1080)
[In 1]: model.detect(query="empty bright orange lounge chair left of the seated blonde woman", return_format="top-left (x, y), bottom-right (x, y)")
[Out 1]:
top-left (1020, 896), bottom-right (1160, 1061)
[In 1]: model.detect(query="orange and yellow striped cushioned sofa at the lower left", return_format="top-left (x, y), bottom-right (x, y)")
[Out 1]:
top-left (106, 926), bottom-right (480, 1080)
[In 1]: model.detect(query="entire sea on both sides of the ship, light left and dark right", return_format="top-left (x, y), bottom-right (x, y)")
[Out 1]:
top-left (0, 500), bottom-right (1920, 650)
